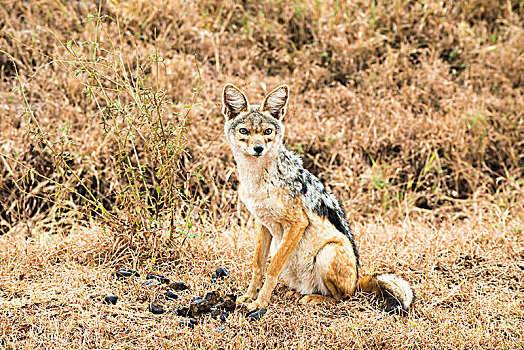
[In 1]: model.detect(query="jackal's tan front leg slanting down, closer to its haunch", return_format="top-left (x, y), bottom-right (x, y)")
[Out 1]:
top-left (247, 215), bottom-right (309, 310)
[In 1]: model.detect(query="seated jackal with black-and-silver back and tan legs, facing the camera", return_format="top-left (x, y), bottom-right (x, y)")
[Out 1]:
top-left (222, 84), bottom-right (414, 314)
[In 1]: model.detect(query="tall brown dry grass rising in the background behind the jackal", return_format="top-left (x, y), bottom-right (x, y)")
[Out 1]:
top-left (0, 0), bottom-right (524, 232)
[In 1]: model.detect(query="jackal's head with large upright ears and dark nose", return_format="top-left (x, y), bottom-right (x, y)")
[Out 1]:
top-left (222, 84), bottom-right (289, 158)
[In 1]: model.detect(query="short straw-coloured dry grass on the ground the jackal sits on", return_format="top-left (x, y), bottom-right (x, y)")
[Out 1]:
top-left (0, 221), bottom-right (524, 349)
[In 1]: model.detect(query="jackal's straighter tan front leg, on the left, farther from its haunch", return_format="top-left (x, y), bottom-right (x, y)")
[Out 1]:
top-left (237, 221), bottom-right (272, 304)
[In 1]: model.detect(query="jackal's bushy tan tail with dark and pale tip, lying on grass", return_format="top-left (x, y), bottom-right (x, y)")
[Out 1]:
top-left (357, 273), bottom-right (415, 315)
